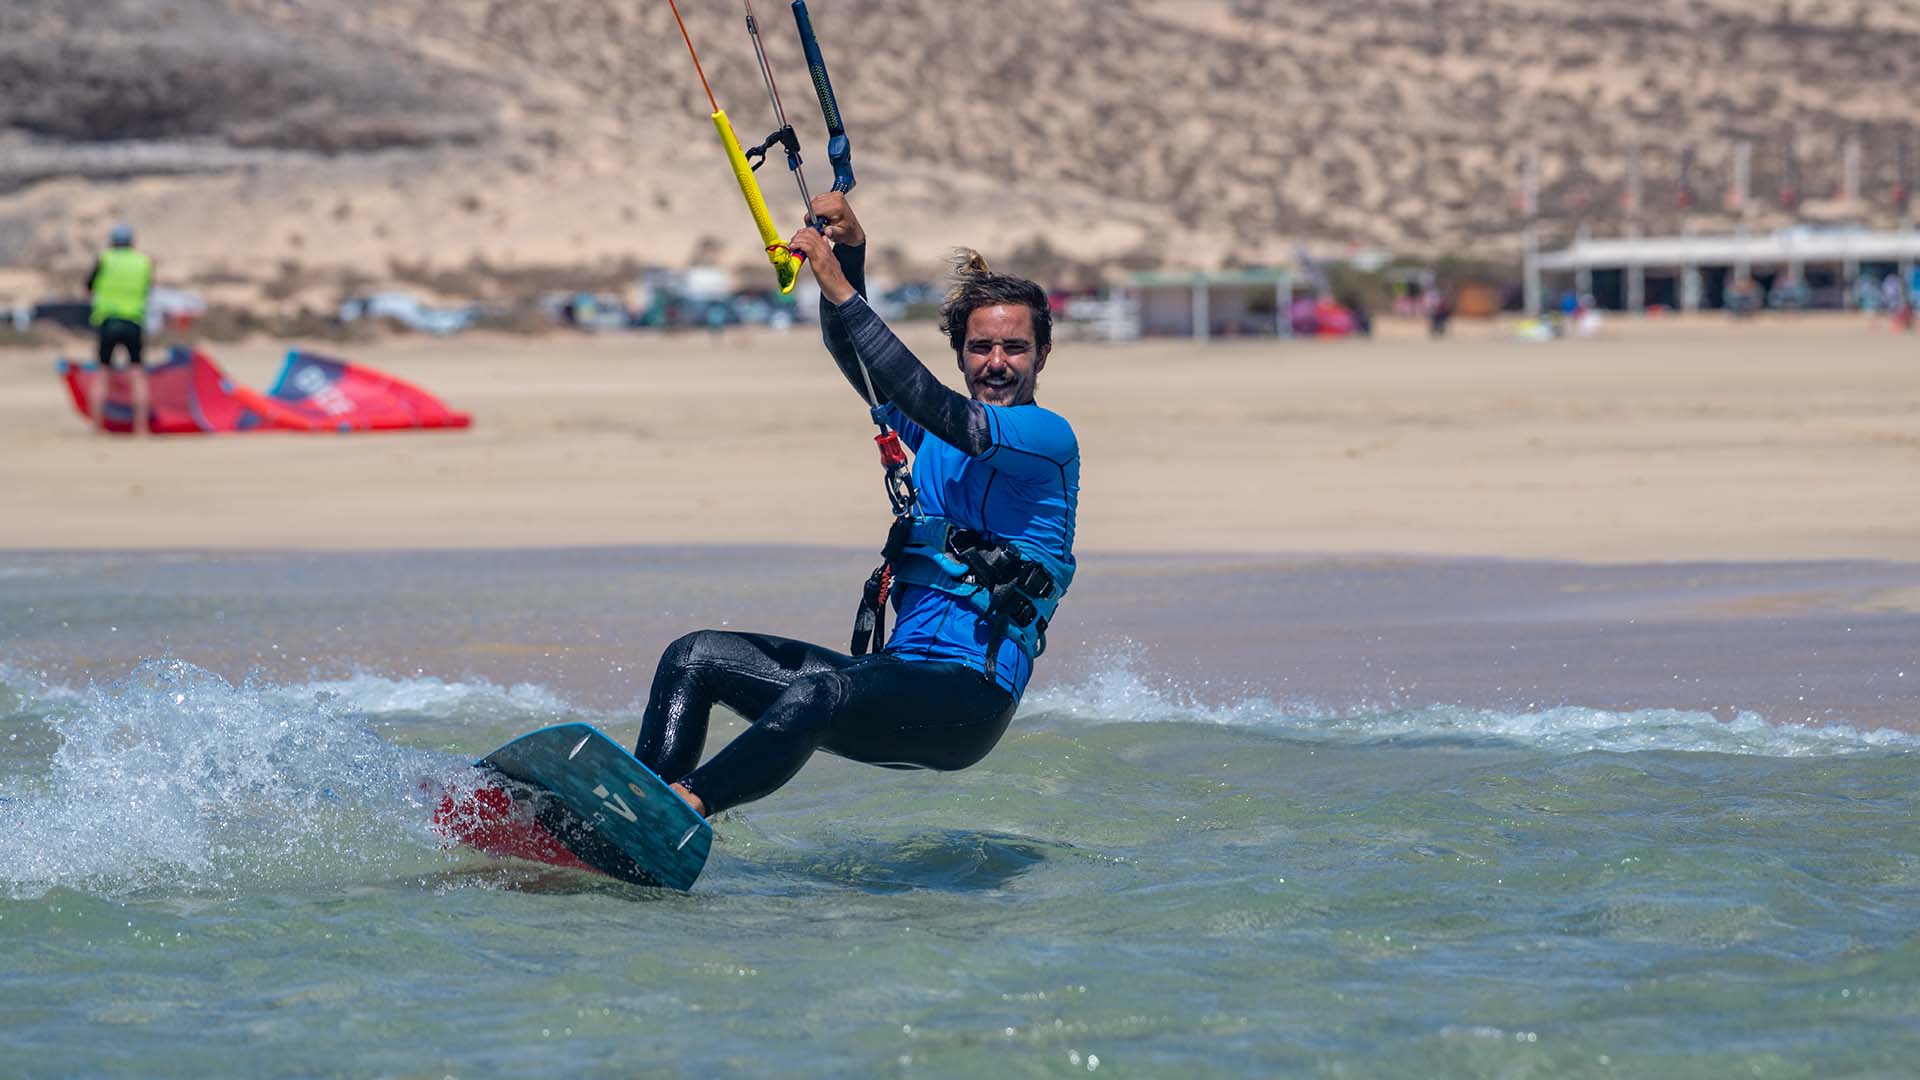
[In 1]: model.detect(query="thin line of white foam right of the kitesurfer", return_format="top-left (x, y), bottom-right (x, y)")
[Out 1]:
top-left (1021, 655), bottom-right (1920, 757)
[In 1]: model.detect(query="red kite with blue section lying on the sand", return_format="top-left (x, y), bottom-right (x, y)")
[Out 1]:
top-left (58, 346), bottom-right (472, 434)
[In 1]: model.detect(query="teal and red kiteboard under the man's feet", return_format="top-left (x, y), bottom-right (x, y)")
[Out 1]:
top-left (434, 724), bottom-right (712, 892)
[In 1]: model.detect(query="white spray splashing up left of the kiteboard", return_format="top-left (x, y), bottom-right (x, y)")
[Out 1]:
top-left (0, 661), bottom-right (538, 897)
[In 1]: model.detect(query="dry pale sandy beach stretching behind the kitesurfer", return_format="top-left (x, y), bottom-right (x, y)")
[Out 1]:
top-left (0, 317), bottom-right (1920, 557)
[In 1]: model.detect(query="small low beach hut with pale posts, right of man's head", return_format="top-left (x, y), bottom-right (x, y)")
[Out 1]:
top-left (1125, 267), bottom-right (1294, 342)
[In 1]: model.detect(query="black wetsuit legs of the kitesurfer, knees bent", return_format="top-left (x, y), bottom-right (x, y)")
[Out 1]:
top-left (634, 630), bottom-right (1018, 813)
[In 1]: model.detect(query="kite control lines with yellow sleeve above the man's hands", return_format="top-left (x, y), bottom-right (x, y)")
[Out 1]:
top-left (666, 0), bottom-right (854, 294)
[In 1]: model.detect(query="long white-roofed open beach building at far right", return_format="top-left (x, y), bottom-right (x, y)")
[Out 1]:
top-left (1526, 227), bottom-right (1920, 315)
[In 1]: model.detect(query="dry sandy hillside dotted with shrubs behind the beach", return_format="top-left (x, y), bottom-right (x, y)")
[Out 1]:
top-left (0, 0), bottom-right (1920, 302)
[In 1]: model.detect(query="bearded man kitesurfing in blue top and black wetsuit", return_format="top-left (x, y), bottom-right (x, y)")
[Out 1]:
top-left (634, 192), bottom-right (1079, 815)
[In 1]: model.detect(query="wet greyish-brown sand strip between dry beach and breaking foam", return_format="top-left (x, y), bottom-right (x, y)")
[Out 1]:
top-left (0, 546), bottom-right (1920, 732)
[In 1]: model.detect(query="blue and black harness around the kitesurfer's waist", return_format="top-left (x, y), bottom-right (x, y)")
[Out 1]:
top-left (852, 513), bottom-right (1062, 678)
